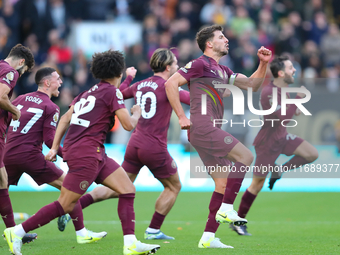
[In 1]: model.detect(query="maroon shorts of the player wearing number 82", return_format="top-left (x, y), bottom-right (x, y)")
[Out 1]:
top-left (63, 154), bottom-right (120, 195)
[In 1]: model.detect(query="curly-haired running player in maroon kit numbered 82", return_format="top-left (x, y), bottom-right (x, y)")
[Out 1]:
top-left (4, 50), bottom-right (160, 255)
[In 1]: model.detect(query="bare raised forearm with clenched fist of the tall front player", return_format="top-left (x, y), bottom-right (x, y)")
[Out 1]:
top-left (234, 46), bottom-right (272, 91)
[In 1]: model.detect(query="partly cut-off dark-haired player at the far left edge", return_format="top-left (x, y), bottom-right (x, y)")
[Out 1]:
top-left (0, 44), bottom-right (37, 243)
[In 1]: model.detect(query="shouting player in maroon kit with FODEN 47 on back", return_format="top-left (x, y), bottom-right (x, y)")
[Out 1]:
top-left (4, 67), bottom-right (107, 243)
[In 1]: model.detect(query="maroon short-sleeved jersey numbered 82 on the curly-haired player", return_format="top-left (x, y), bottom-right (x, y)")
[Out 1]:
top-left (63, 82), bottom-right (125, 161)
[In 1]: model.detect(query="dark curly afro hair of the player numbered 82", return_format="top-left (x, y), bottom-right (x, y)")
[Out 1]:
top-left (91, 50), bottom-right (125, 80)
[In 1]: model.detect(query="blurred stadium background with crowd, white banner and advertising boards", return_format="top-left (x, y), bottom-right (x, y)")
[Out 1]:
top-left (0, 0), bottom-right (340, 191)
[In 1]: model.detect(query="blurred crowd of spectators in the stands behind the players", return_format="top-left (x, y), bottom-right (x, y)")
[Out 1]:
top-left (0, 0), bottom-right (340, 143)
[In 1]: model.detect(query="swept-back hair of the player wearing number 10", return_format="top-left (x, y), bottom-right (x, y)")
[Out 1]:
top-left (150, 48), bottom-right (175, 73)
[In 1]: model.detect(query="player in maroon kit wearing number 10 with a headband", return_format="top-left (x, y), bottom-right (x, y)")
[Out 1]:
top-left (71, 48), bottom-right (190, 240)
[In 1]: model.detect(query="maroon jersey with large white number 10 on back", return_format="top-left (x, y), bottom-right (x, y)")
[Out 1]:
top-left (122, 76), bottom-right (189, 149)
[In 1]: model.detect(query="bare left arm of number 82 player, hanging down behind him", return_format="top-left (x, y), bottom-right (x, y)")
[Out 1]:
top-left (45, 105), bottom-right (74, 162)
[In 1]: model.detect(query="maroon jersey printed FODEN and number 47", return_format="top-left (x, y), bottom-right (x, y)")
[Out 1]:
top-left (5, 91), bottom-right (60, 157)
